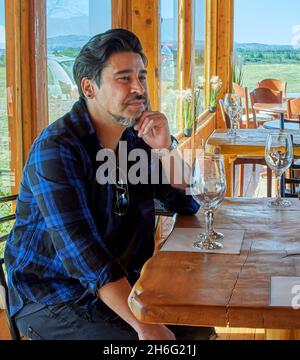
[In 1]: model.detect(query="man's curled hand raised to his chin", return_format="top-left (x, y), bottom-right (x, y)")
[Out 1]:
top-left (134, 111), bottom-right (171, 149)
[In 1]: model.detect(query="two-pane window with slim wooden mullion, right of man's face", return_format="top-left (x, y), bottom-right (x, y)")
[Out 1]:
top-left (160, 0), bottom-right (206, 136)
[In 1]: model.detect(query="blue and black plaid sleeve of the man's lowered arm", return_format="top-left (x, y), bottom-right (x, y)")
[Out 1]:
top-left (27, 138), bottom-right (127, 293)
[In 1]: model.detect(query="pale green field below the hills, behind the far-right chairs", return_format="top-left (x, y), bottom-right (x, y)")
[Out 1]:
top-left (243, 63), bottom-right (300, 92)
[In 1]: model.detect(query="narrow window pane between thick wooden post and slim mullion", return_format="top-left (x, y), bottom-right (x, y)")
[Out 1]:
top-left (160, 0), bottom-right (179, 134)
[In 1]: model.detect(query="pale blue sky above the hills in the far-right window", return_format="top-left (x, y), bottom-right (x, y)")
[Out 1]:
top-left (236, 0), bottom-right (300, 45)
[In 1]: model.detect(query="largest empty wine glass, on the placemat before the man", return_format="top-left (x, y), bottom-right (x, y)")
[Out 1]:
top-left (192, 155), bottom-right (226, 250)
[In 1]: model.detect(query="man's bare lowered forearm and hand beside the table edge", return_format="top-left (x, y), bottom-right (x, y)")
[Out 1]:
top-left (98, 278), bottom-right (175, 340)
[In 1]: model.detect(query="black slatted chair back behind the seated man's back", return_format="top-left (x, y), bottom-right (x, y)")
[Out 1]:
top-left (0, 195), bottom-right (21, 340)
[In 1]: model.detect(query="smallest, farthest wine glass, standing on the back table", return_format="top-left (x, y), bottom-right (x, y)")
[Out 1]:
top-left (224, 94), bottom-right (242, 138)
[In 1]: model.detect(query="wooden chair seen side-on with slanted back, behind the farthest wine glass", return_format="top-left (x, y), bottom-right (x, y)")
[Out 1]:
top-left (232, 83), bottom-right (274, 129)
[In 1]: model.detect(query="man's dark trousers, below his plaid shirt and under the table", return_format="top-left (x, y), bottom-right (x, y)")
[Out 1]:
top-left (16, 300), bottom-right (215, 340)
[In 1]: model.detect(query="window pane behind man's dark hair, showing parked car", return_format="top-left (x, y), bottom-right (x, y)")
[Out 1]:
top-left (47, 0), bottom-right (111, 122)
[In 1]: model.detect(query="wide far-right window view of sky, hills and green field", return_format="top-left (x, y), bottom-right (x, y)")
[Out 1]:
top-left (234, 0), bottom-right (300, 93)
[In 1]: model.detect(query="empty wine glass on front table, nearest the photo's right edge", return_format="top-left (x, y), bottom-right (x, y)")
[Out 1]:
top-left (265, 131), bottom-right (293, 207)
